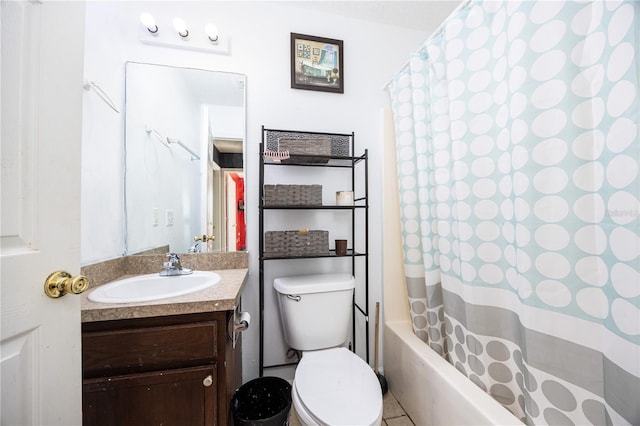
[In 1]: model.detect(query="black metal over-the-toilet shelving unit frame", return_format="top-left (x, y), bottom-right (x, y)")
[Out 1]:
top-left (258, 126), bottom-right (369, 377)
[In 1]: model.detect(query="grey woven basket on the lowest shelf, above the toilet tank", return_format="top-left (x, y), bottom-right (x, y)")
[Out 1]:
top-left (264, 231), bottom-right (329, 257)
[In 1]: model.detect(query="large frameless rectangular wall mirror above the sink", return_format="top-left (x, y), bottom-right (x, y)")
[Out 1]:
top-left (125, 62), bottom-right (246, 254)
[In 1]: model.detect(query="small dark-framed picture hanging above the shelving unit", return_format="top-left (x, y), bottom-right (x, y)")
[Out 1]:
top-left (291, 33), bottom-right (344, 93)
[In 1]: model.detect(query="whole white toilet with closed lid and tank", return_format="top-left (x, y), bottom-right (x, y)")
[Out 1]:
top-left (273, 274), bottom-right (382, 426)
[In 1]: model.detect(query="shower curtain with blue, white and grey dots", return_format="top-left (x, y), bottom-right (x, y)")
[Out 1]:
top-left (389, 1), bottom-right (640, 425)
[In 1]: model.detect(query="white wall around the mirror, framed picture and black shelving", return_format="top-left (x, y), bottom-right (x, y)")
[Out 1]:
top-left (82, 1), bottom-right (444, 380)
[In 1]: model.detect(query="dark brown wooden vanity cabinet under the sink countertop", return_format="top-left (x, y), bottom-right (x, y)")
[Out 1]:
top-left (82, 312), bottom-right (242, 426)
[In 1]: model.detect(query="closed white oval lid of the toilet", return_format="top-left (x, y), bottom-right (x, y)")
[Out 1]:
top-left (294, 348), bottom-right (382, 425)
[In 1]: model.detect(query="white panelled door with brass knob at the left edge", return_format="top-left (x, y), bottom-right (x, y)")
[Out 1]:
top-left (0, 1), bottom-right (84, 426)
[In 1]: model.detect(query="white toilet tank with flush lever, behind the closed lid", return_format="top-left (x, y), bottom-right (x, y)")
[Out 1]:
top-left (273, 274), bottom-right (355, 351)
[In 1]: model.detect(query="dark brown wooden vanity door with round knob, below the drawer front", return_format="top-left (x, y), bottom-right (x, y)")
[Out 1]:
top-left (83, 365), bottom-right (217, 426)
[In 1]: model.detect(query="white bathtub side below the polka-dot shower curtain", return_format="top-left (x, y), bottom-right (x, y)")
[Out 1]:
top-left (384, 320), bottom-right (522, 426)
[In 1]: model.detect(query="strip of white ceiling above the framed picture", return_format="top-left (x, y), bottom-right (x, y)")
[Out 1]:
top-left (283, 0), bottom-right (461, 34)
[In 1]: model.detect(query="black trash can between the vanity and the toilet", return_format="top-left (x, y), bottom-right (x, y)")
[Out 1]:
top-left (231, 377), bottom-right (291, 426)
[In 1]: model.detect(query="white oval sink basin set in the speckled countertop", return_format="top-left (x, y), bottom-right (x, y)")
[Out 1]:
top-left (89, 271), bottom-right (220, 303)
